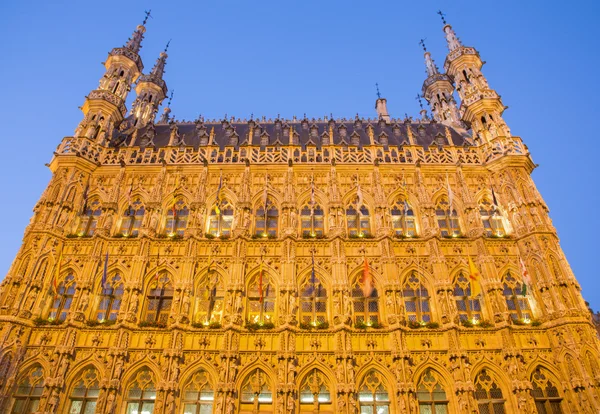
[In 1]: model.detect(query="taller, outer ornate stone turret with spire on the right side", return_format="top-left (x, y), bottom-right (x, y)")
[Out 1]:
top-left (440, 12), bottom-right (510, 142)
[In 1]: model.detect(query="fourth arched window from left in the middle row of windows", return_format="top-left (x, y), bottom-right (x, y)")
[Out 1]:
top-left (195, 266), bottom-right (225, 325)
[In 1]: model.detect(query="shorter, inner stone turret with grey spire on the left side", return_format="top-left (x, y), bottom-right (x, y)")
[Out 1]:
top-left (131, 43), bottom-right (169, 129)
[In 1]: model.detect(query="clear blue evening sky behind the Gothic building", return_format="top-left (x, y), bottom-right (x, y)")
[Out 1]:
top-left (0, 0), bottom-right (600, 310)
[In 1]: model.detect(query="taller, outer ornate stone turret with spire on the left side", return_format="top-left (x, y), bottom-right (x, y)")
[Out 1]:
top-left (75, 12), bottom-right (150, 144)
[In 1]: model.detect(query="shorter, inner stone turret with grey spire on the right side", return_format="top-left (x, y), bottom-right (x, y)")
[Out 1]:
top-left (419, 39), bottom-right (460, 126)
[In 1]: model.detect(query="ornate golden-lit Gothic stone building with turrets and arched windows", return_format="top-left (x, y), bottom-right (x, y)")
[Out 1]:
top-left (0, 11), bottom-right (600, 414)
